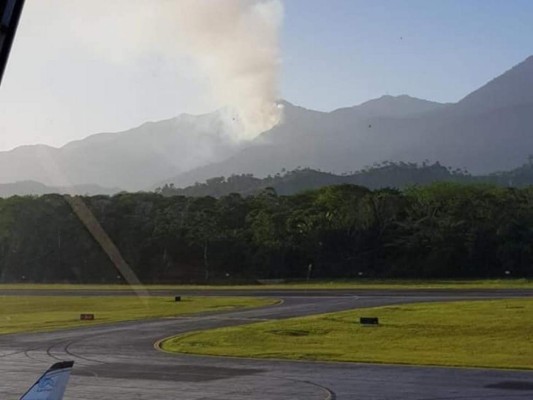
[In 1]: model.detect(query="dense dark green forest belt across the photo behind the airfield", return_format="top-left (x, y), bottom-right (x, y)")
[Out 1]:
top-left (0, 183), bottom-right (533, 283)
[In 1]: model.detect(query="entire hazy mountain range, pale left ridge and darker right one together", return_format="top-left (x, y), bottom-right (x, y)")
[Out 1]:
top-left (0, 57), bottom-right (533, 194)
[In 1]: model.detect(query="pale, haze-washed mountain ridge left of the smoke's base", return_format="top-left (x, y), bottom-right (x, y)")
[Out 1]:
top-left (0, 110), bottom-right (244, 190)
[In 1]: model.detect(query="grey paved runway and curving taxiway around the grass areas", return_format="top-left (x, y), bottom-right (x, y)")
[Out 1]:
top-left (0, 290), bottom-right (533, 400)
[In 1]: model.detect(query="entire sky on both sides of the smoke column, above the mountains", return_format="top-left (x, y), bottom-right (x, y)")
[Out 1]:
top-left (0, 0), bottom-right (533, 150)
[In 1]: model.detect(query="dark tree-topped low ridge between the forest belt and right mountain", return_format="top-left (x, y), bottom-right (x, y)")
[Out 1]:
top-left (156, 157), bottom-right (533, 197)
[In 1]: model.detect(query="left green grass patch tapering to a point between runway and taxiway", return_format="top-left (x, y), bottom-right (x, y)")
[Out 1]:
top-left (0, 296), bottom-right (276, 334)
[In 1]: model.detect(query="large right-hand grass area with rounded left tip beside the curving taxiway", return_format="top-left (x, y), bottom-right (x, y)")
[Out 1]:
top-left (161, 299), bottom-right (533, 369)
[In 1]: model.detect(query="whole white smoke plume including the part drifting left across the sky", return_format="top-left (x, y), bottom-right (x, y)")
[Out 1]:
top-left (60, 0), bottom-right (283, 139)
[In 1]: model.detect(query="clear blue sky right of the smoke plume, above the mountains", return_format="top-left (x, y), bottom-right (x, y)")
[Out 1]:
top-left (282, 0), bottom-right (533, 110)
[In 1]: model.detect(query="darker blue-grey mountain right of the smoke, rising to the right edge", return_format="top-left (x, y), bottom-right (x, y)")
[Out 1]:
top-left (161, 57), bottom-right (533, 187)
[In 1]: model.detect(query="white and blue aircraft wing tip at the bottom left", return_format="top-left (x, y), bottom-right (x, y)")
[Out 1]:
top-left (20, 361), bottom-right (74, 400)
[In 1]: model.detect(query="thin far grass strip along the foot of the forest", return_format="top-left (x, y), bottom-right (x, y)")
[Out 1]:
top-left (0, 279), bottom-right (533, 290)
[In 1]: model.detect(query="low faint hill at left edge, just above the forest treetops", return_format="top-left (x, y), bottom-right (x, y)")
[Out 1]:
top-left (0, 181), bottom-right (121, 197)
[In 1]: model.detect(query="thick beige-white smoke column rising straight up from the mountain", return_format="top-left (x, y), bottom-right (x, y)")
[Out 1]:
top-left (175, 0), bottom-right (283, 138)
